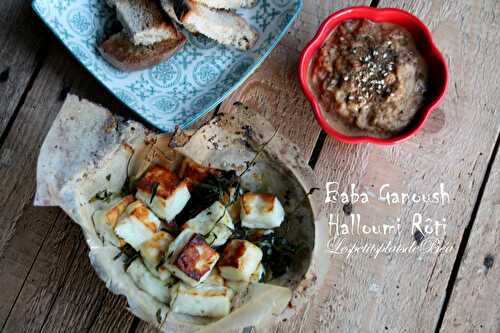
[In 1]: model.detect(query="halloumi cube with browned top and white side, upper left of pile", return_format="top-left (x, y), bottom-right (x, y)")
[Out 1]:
top-left (136, 165), bottom-right (191, 221)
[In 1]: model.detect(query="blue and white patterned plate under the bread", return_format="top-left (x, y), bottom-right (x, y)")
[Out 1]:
top-left (33, 0), bottom-right (302, 131)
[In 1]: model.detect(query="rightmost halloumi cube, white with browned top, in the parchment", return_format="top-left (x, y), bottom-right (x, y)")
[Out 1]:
top-left (240, 192), bottom-right (285, 229)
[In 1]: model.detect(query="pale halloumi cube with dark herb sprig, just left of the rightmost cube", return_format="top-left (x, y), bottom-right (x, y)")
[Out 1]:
top-left (182, 201), bottom-right (234, 247)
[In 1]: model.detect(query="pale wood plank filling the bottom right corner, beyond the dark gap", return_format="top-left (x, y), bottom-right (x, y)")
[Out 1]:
top-left (441, 139), bottom-right (500, 333)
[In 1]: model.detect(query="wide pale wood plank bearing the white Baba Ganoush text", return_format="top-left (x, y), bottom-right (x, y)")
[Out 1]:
top-left (290, 0), bottom-right (500, 332)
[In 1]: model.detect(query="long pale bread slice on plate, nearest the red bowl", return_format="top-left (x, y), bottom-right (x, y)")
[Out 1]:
top-left (161, 0), bottom-right (258, 50)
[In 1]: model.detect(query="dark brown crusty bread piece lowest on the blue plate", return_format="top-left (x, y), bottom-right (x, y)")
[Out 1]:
top-left (99, 32), bottom-right (186, 72)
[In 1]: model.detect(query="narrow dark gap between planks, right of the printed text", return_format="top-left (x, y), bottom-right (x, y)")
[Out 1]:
top-left (435, 133), bottom-right (500, 333)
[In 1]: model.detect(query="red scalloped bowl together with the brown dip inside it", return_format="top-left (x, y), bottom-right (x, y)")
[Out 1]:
top-left (299, 7), bottom-right (448, 144)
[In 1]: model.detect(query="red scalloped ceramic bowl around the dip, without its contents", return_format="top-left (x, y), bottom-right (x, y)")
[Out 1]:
top-left (299, 7), bottom-right (448, 145)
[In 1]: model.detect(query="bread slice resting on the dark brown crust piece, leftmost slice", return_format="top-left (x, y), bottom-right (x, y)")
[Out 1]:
top-left (115, 0), bottom-right (177, 45)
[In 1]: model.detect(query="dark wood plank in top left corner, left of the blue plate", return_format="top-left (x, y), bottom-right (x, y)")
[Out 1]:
top-left (0, 0), bottom-right (47, 137)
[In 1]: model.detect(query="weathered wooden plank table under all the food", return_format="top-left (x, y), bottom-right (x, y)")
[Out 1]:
top-left (0, 0), bottom-right (500, 333)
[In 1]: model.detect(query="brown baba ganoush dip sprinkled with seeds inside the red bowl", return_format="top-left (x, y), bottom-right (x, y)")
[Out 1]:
top-left (311, 19), bottom-right (428, 137)
